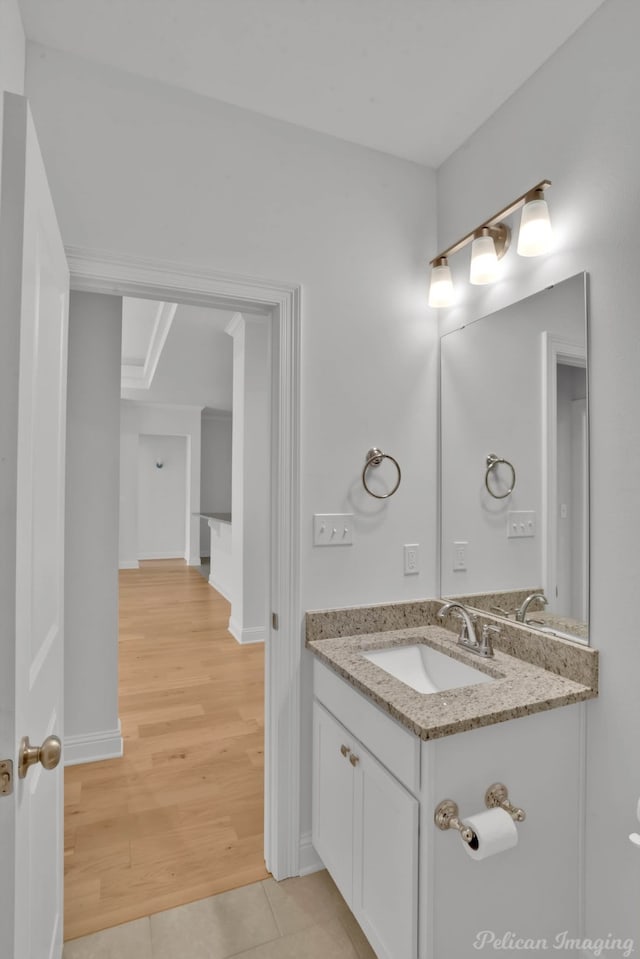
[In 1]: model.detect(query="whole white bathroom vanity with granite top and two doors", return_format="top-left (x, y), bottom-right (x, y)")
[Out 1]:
top-left (307, 600), bottom-right (598, 959)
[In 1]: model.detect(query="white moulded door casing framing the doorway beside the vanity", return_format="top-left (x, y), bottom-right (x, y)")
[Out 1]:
top-left (62, 254), bottom-right (300, 940)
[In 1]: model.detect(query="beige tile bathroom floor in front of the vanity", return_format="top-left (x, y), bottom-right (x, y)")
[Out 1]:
top-left (63, 871), bottom-right (376, 959)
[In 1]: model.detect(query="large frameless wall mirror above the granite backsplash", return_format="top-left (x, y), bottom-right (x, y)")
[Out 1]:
top-left (440, 273), bottom-right (589, 642)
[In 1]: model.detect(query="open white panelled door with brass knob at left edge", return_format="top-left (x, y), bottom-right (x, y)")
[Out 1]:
top-left (0, 94), bottom-right (69, 959)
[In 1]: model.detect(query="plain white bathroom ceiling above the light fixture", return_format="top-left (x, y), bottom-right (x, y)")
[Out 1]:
top-left (20, 0), bottom-right (603, 167)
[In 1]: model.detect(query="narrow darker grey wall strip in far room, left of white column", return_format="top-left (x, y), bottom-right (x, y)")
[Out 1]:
top-left (200, 410), bottom-right (232, 556)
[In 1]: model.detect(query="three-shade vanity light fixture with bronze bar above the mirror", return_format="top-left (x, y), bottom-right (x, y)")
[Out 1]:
top-left (429, 180), bottom-right (551, 307)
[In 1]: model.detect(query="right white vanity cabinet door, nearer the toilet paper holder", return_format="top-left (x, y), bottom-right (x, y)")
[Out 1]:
top-left (352, 750), bottom-right (419, 959)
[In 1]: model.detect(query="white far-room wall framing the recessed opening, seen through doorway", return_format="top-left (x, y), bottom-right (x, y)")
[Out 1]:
top-left (119, 400), bottom-right (202, 569)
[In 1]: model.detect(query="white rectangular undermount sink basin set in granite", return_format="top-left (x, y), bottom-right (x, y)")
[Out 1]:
top-left (362, 643), bottom-right (493, 693)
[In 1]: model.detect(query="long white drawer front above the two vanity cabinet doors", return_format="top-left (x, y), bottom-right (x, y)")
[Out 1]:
top-left (313, 659), bottom-right (420, 795)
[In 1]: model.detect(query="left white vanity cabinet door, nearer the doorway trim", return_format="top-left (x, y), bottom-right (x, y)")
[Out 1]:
top-left (313, 703), bottom-right (354, 905)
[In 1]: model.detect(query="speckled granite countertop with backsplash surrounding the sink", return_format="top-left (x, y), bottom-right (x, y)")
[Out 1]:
top-left (306, 601), bottom-right (598, 740)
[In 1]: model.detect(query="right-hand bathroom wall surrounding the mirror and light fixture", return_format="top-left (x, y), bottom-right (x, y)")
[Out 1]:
top-left (438, 0), bottom-right (640, 947)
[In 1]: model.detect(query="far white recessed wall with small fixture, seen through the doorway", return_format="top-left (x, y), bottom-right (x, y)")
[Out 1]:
top-left (138, 434), bottom-right (187, 559)
